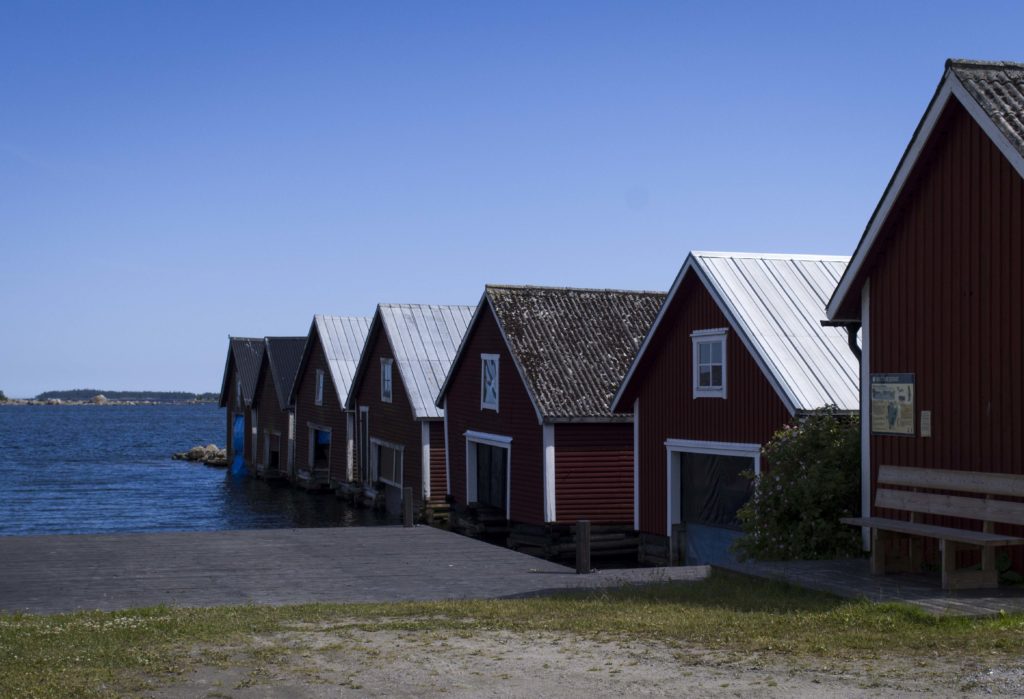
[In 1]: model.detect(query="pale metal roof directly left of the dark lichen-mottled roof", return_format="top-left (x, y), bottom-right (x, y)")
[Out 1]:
top-left (347, 304), bottom-right (474, 420)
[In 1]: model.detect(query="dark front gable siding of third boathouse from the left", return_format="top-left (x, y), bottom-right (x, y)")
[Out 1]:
top-left (294, 330), bottom-right (348, 482)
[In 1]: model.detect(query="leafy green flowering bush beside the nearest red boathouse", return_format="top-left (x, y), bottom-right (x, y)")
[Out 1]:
top-left (735, 406), bottom-right (860, 560)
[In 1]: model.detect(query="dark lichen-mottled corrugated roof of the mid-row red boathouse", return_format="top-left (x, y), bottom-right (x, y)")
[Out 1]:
top-left (437, 286), bottom-right (665, 423)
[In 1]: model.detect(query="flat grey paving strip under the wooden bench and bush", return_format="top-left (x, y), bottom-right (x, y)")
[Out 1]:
top-left (719, 559), bottom-right (1024, 616)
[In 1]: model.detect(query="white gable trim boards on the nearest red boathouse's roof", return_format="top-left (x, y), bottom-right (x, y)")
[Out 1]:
top-left (825, 69), bottom-right (1024, 320)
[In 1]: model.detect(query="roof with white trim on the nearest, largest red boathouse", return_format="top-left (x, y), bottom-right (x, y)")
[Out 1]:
top-left (827, 59), bottom-right (1024, 320)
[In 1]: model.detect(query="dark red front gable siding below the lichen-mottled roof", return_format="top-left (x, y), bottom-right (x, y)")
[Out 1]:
top-left (447, 307), bottom-right (544, 524)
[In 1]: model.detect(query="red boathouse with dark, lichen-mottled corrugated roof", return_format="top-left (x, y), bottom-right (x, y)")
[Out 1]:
top-left (437, 286), bottom-right (665, 557)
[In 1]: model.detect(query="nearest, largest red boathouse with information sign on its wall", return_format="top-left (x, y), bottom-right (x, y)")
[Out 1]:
top-left (827, 60), bottom-right (1024, 583)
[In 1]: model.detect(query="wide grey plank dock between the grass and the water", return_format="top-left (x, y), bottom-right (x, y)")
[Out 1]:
top-left (0, 526), bottom-right (709, 614)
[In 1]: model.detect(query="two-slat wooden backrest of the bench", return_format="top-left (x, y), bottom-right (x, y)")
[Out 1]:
top-left (874, 466), bottom-right (1024, 525)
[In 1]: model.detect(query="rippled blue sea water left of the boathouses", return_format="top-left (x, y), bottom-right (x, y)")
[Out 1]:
top-left (0, 404), bottom-right (383, 535)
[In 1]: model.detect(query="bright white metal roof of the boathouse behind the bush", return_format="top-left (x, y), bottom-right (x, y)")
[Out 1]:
top-left (612, 252), bottom-right (859, 413)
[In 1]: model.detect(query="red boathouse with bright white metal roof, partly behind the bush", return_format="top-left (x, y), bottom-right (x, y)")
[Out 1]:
top-left (612, 253), bottom-right (857, 564)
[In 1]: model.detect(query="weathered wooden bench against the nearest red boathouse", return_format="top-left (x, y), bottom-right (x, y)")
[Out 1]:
top-left (842, 466), bottom-right (1024, 589)
